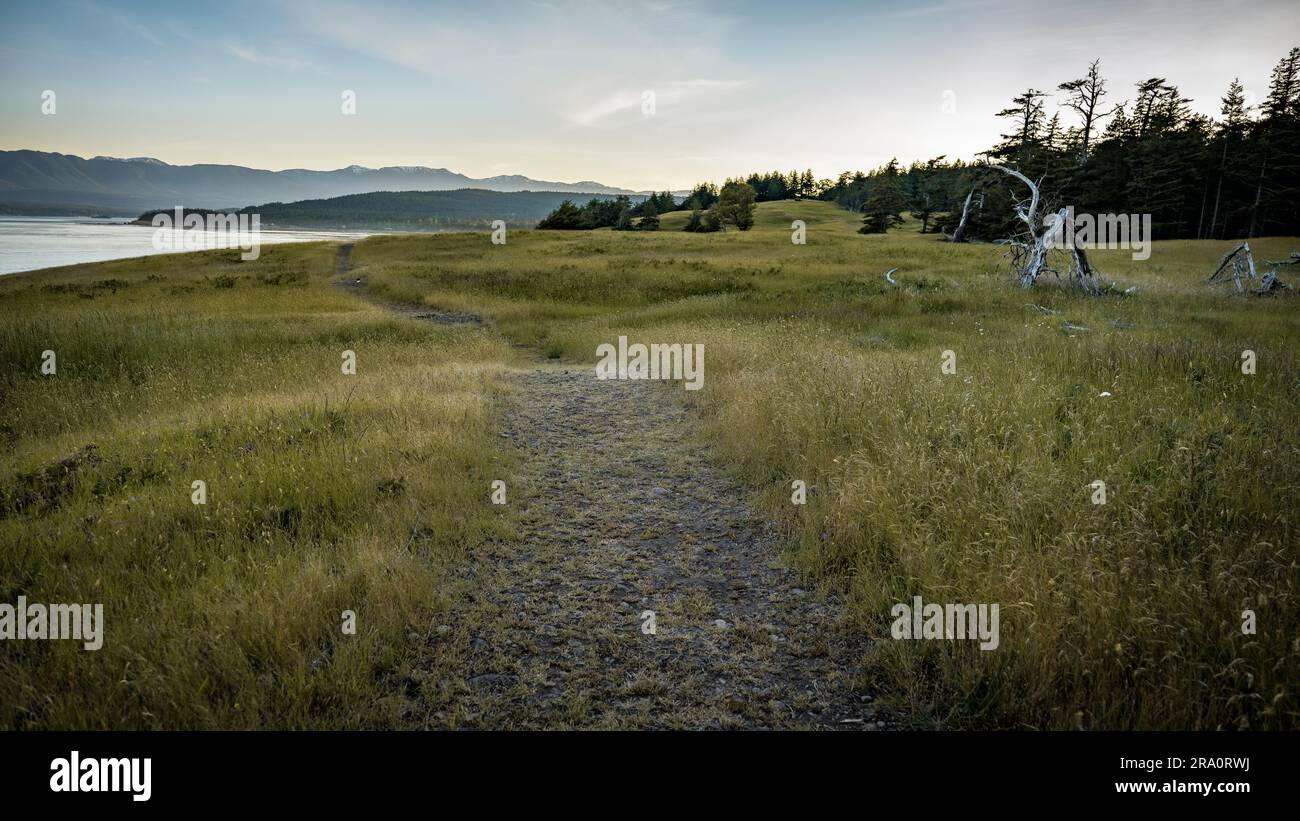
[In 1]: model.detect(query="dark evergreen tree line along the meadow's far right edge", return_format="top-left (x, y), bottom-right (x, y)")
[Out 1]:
top-left (538, 48), bottom-right (1300, 239)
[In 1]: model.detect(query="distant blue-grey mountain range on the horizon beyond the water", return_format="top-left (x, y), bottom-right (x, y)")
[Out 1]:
top-left (0, 151), bottom-right (650, 216)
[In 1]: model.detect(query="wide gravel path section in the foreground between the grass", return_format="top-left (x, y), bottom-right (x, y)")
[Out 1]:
top-left (332, 244), bottom-right (891, 729)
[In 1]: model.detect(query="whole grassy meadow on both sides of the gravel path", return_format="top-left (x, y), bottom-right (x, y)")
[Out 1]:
top-left (0, 201), bottom-right (1300, 729)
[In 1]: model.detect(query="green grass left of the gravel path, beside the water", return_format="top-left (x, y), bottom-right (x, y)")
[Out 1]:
top-left (0, 244), bottom-right (511, 727)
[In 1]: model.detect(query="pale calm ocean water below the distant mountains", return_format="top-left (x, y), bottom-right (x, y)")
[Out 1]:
top-left (0, 217), bottom-right (367, 274)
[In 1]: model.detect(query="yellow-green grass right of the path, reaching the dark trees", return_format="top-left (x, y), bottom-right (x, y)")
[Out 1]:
top-left (358, 203), bottom-right (1300, 729)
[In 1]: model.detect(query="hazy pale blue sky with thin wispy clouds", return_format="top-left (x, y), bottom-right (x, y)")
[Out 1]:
top-left (0, 0), bottom-right (1300, 190)
